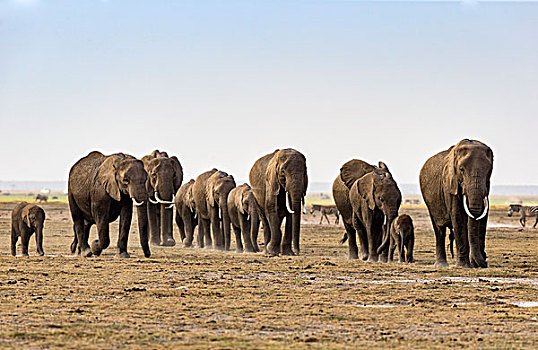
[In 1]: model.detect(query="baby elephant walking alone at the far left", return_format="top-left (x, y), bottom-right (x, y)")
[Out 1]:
top-left (11, 202), bottom-right (45, 256)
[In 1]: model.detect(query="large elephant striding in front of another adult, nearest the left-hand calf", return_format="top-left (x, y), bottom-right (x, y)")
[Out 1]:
top-left (67, 151), bottom-right (151, 258)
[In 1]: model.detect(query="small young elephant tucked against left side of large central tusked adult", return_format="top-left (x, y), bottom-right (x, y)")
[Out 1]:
top-left (228, 184), bottom-right (260, 253)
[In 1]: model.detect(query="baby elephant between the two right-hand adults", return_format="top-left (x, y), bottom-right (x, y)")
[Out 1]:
top-left (389, 214), bottom-right (415, 263)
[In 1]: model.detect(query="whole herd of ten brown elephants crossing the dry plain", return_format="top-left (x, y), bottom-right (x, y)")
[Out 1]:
top-left (11, 139), bottom-right (493, 267)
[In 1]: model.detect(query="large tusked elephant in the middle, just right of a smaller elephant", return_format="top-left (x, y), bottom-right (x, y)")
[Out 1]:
top-left (249, 148), bottom-right (308, 255)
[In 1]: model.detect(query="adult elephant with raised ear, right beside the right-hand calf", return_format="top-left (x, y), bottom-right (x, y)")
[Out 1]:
top-left (333, 159), bottom-right (402, 261)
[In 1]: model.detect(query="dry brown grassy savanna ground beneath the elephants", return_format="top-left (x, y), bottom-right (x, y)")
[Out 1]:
top-left (0, 198), bottom-right (538, 349)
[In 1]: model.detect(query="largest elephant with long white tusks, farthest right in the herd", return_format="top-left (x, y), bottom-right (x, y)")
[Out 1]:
top-left (420, 139), bottom-right (493, 267)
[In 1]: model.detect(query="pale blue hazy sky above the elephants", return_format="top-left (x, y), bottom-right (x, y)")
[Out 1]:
top-left (0, 0), bottom-right (538, 184)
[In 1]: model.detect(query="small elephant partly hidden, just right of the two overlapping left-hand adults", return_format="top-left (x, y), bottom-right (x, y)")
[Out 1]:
top-left (175, 179), bottom-right (198, 248)
